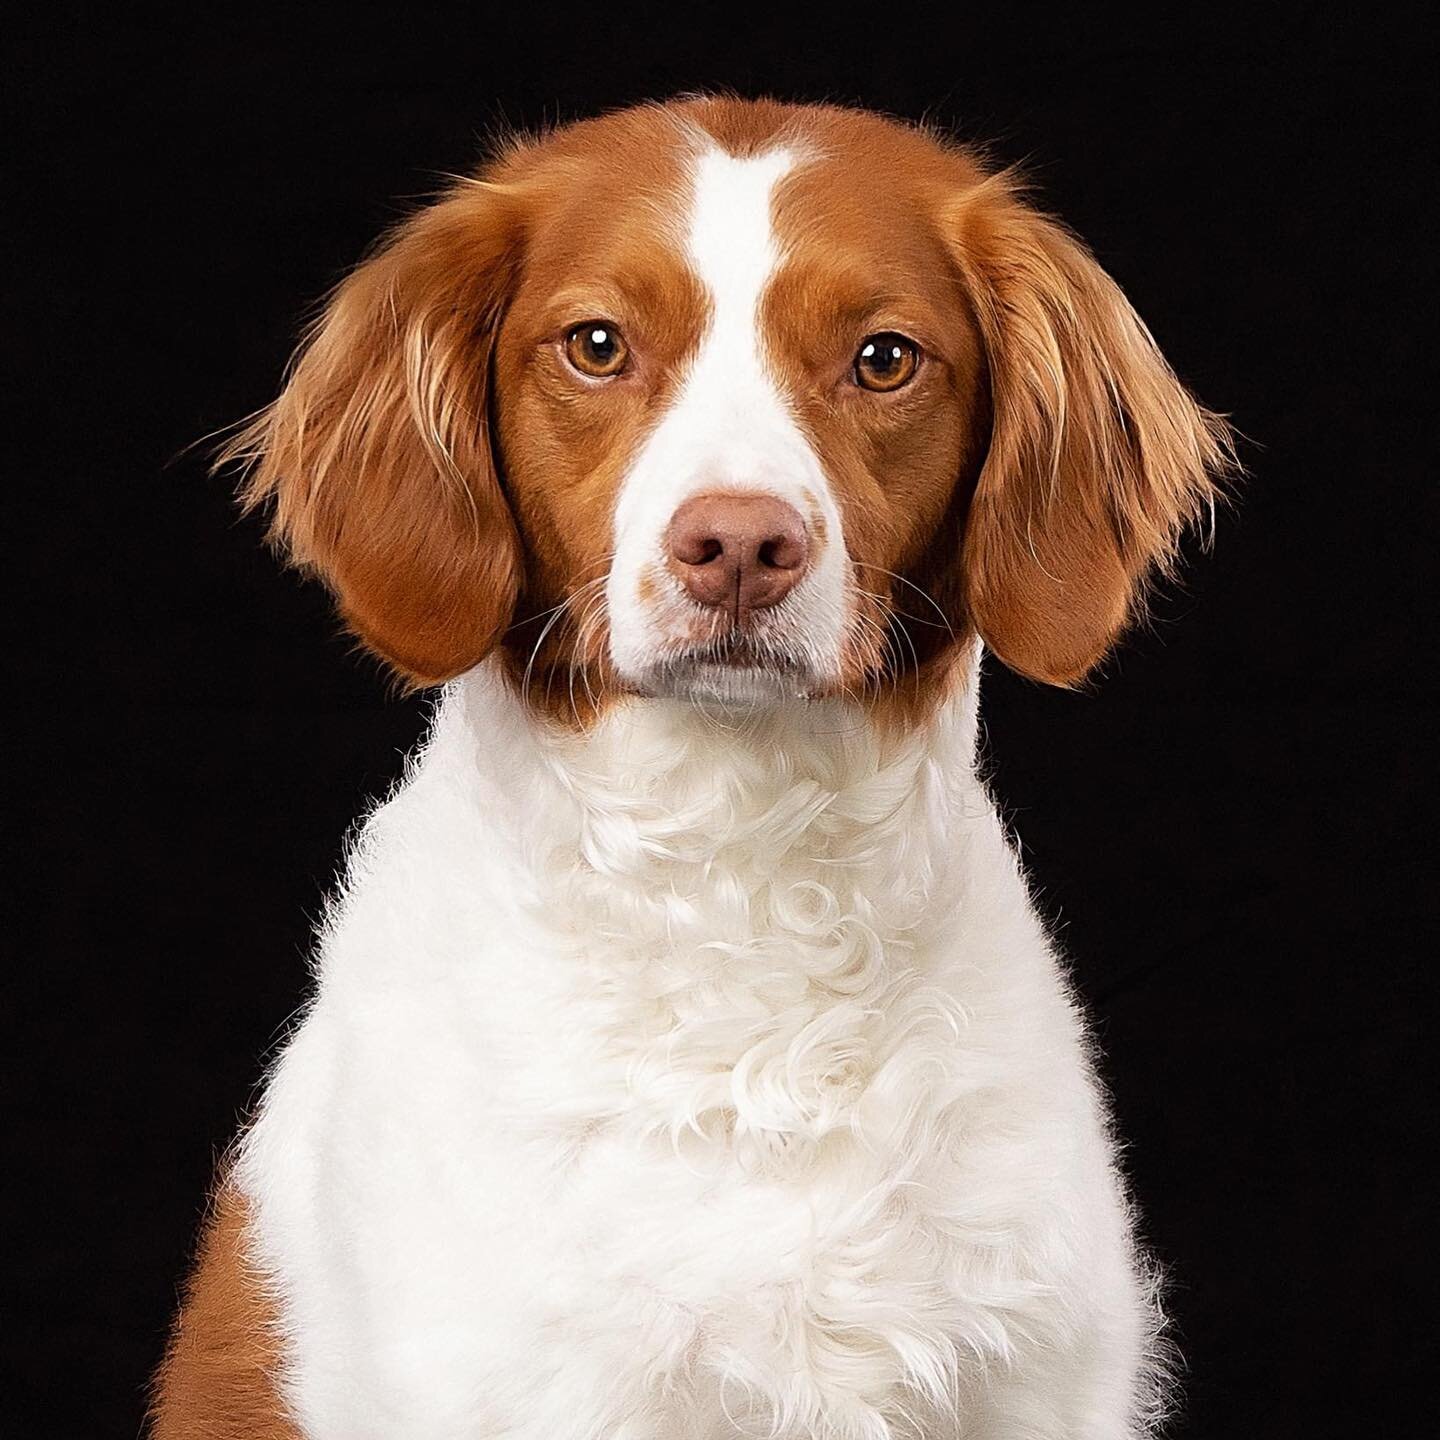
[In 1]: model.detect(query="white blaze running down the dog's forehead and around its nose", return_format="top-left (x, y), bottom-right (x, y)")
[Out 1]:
top-left (608, 145), bottom-right (847, 688)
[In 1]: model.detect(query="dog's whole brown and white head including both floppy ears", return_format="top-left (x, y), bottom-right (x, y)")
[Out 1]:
top-left (230, 99), bottom-right (1227, 721)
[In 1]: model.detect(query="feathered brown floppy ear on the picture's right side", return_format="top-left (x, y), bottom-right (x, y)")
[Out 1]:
top-left (948, 176), bottom-right (1233, 685)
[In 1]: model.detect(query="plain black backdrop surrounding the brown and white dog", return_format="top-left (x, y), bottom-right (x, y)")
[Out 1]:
top-left (0, 0), bottom-right (1436, 1440)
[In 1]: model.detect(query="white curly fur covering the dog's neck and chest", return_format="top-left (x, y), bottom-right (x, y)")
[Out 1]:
top-left (239, 667), bottom-right (1153, 1440)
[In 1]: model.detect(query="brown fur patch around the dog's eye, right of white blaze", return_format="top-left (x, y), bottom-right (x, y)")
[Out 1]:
top-left (765, 98), bottom-right (986, 724)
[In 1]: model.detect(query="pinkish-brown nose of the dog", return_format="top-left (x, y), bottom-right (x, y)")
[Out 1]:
top-left (667, 495), bottom-right (809, 625)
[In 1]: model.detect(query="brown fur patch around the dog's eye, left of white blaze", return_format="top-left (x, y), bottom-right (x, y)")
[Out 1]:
top-left (495, 107), bottom-right (707, 724)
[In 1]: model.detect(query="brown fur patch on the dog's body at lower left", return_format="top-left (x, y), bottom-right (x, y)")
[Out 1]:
top-left (150, 1184), bottom-right (301, 1440)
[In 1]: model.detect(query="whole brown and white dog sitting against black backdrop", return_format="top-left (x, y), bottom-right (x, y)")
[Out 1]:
top-left (151, 96), bottom-right (1233, 1440)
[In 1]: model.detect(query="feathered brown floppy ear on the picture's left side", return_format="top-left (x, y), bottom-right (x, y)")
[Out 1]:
top-left (220, 181), bottom-right (521, 685)
